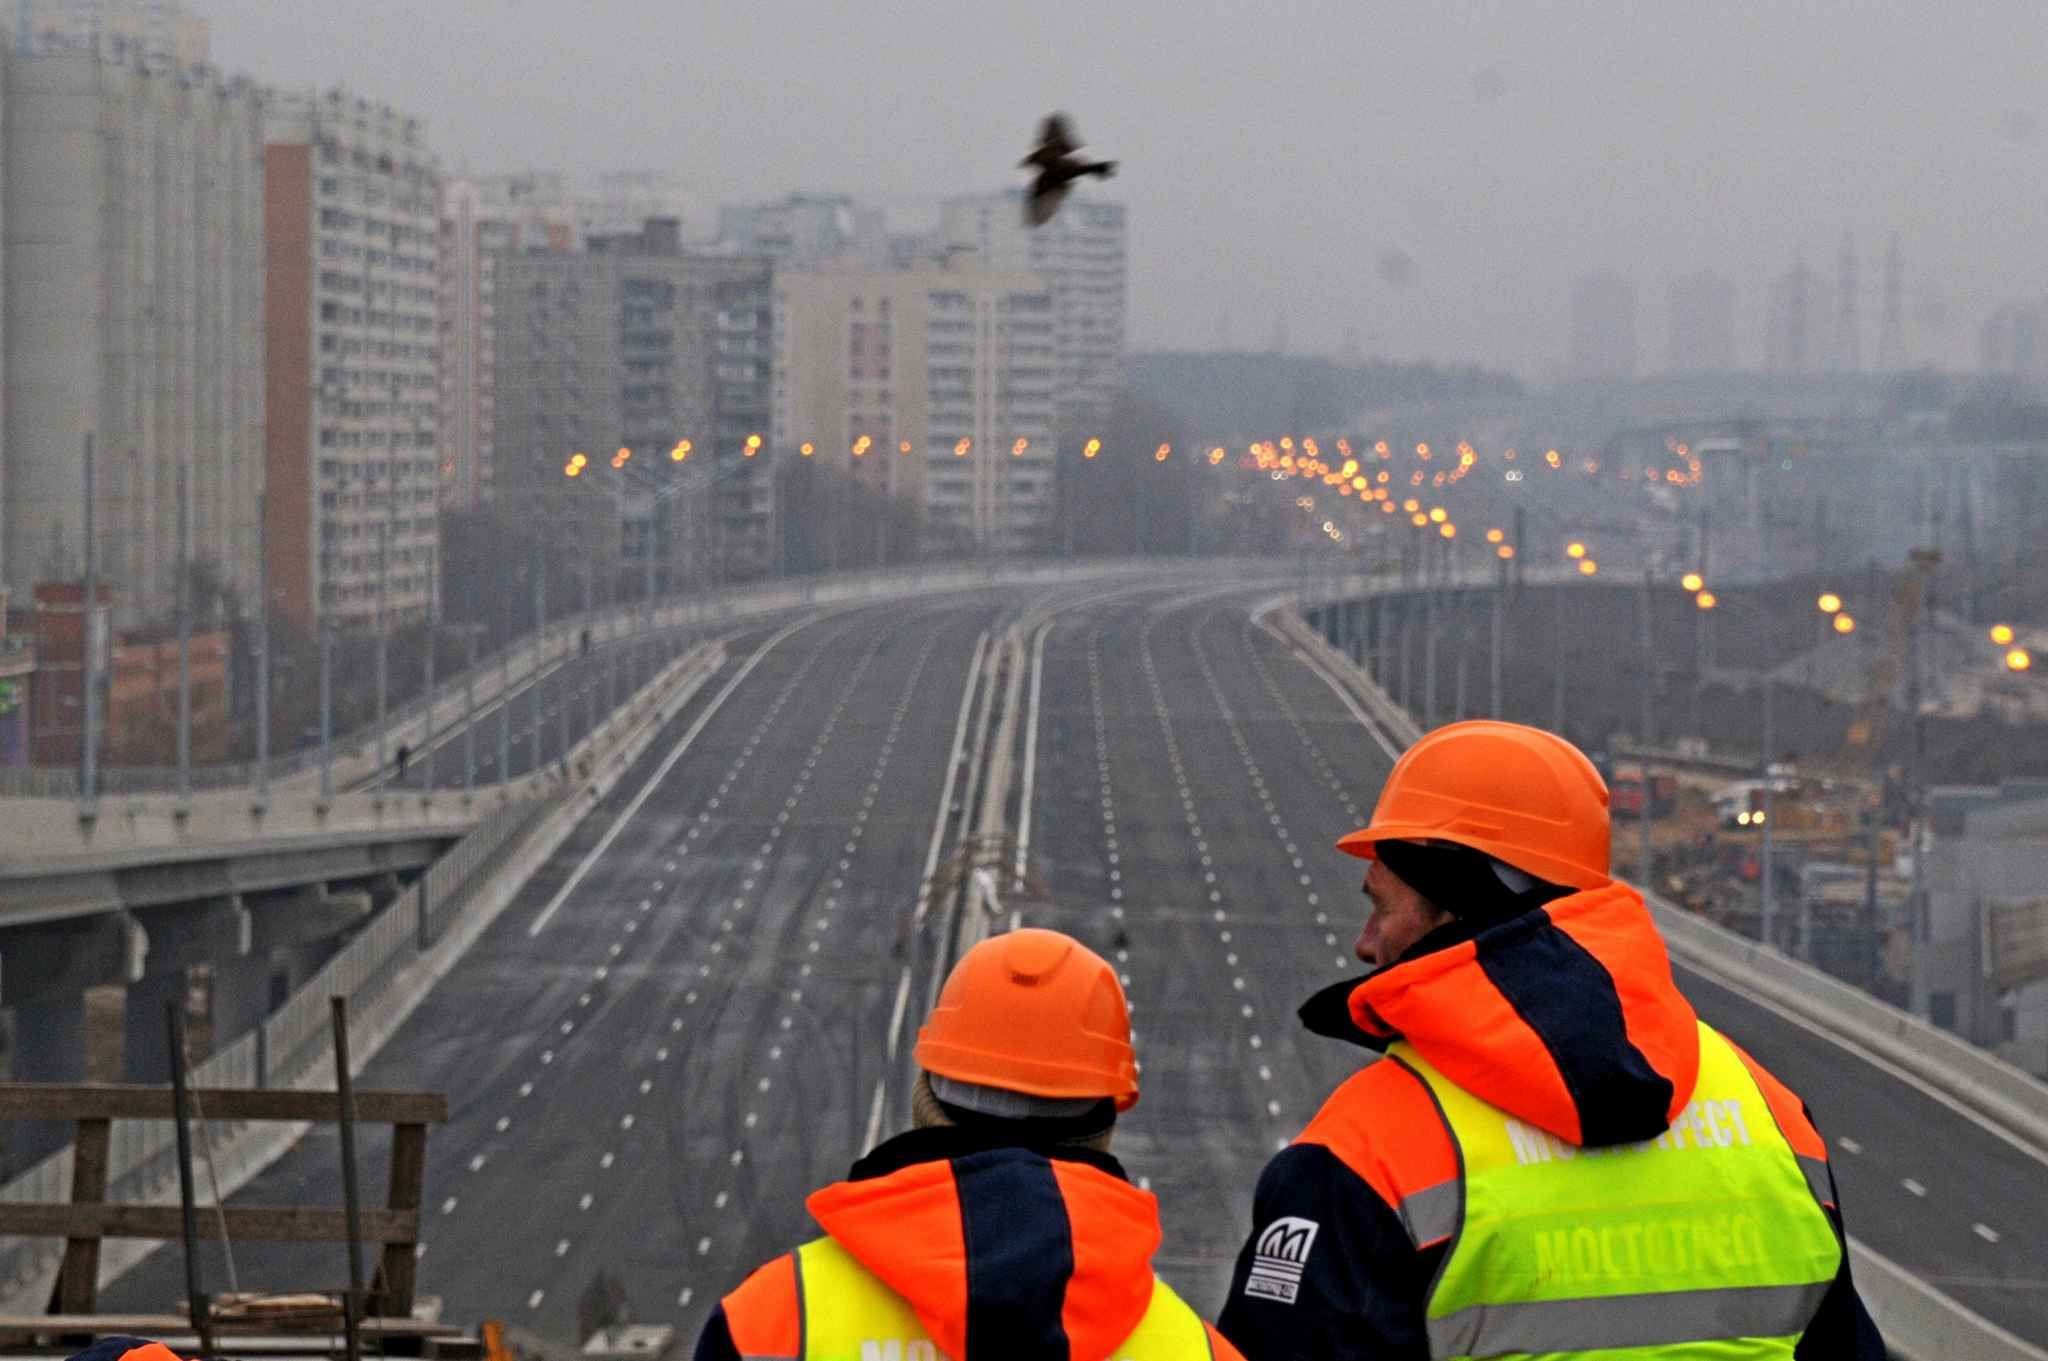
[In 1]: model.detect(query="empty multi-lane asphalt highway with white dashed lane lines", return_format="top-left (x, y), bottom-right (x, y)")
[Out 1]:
top-left (8, 569), bottom-right (2048, 1357)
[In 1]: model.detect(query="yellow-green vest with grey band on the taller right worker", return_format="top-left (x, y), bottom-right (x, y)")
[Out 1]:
top-left (1389, 1023), bottom-right (1841, 1361)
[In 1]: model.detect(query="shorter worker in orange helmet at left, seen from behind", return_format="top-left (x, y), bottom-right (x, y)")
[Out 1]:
top-left (696, 929), bottom-right (1241, 1361)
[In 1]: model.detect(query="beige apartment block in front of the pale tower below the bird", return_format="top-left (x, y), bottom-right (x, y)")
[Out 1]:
top-left (774, 260), bottom-right (1059, 553)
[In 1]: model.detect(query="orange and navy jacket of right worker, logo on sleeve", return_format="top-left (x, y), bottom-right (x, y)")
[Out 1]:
top-left (1217, 884), bottom-right (1884, 1361)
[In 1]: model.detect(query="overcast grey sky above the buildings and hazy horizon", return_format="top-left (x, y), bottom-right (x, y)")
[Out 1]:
top-left (193, 0), bottom-right (2048, 377)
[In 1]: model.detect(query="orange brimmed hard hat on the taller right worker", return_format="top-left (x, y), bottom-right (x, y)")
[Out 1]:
top-left (1337, 718), bottom-right (1610, 888)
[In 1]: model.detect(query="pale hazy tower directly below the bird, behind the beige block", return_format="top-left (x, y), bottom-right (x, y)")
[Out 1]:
top-left (938, 190), bottom-right (1126, 440)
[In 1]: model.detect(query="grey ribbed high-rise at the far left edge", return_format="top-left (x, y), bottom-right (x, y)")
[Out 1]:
top-left (0, 35), bottom-right (264, 624)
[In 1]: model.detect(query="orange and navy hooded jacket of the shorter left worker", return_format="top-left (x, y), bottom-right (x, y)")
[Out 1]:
top-left (696, 1128), bottom-right (1243, 1361)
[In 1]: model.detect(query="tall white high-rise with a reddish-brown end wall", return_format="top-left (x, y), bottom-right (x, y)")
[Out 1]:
top-left (264, 90), bottom-right (440, 628)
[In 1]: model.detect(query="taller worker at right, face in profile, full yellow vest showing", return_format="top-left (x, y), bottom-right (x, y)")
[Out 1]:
top-left (1219, 722), bottom-right (1884, 1361)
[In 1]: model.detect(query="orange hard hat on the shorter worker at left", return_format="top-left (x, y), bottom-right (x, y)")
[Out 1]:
top-left (918, 927), bottom-right (1139, 1111)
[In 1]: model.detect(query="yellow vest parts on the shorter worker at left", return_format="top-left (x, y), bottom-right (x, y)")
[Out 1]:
top-left (797, 1238), bottom-right (1212, 1361)
